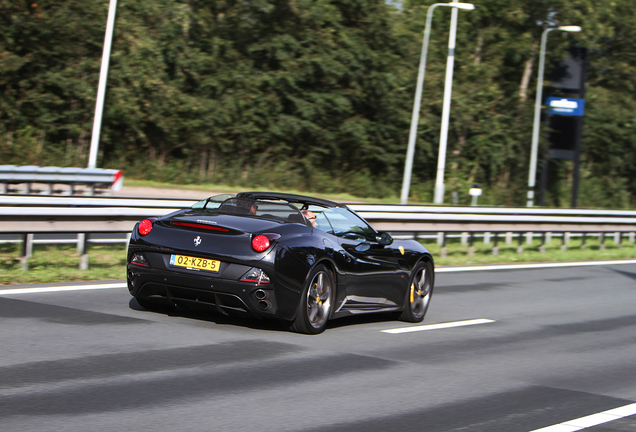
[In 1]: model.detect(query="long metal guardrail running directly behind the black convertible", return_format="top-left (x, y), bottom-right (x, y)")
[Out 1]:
top-left (0, 195), bottom-right (636, 270)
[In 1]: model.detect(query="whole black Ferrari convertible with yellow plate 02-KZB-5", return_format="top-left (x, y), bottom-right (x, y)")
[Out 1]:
top-left (127, 192), bottom-right (434, 334)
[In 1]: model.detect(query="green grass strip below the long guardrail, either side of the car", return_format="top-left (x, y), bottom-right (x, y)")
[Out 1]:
top-left (0, 238), bottom-right (636, 285)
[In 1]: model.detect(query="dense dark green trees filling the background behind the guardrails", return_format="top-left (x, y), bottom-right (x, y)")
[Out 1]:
top-left (0, 0), bottom-right (636, 207)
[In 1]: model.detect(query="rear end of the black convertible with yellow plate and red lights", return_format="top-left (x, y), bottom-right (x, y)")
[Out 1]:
top-left (127, 201), bottom-right (307, 319)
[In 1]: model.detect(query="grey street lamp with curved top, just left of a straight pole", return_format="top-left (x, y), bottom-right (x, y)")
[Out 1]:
top-left (400, 2), bottom-right (475, 204)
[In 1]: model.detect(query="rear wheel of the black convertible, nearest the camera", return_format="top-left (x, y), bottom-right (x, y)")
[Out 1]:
top-left (290, 264), bottom-right (335, 334)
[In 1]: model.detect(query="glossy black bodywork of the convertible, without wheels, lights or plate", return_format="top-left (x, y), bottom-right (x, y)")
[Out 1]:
top-left (127, 194), bottom-right (432, 328)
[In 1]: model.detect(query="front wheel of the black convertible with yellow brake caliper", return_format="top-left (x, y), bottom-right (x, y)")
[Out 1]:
top-left (400, 261), bottom-right (434, 322)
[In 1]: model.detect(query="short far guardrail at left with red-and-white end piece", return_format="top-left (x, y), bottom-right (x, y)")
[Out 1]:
top-left (0, 165), bottom-right (123, 195)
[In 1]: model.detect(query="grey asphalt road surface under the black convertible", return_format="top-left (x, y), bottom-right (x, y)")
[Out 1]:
top-left (0, 264), bottom-right (636, 432)
